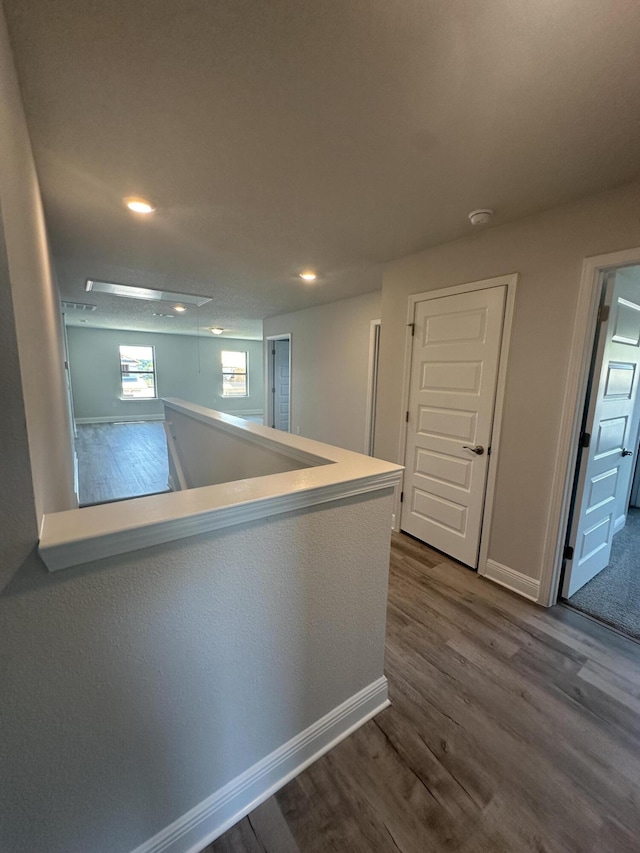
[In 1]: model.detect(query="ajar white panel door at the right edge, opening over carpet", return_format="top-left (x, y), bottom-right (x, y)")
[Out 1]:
top-left (562, 270), bottom-right (640, 598)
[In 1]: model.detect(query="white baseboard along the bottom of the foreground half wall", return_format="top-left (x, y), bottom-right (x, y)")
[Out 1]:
top-left (127, 676), bottom-right (389, 853)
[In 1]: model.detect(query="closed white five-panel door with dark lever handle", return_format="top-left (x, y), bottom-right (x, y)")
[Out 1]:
top-left (400, 286), bottom-right (506, 568)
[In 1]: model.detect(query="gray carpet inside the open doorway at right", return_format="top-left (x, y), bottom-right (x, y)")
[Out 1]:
top-left (567, 508), bottom-right (640, 640)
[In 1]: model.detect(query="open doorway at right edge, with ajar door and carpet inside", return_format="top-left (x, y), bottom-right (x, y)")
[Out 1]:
top-left (560, 264), bottom-right (640, 639)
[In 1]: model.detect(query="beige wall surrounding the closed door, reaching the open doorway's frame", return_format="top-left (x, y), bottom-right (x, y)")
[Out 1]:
top-left (375, 184), bottom-right (640, 579)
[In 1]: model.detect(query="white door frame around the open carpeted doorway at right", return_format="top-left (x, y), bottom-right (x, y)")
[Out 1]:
top-left (538, 247), bottom-right (640, 607)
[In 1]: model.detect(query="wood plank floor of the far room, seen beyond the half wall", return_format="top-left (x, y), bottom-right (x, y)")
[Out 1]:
top-left (76, 421), bottom-right (169, 506)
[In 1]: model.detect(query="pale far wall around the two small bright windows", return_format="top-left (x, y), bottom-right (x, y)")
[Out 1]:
top-left (67, 326), bottom-right (264, 420)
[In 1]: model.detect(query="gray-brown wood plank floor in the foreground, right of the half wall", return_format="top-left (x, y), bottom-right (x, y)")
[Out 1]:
top-left (206, 534), bottom-right (640, 853)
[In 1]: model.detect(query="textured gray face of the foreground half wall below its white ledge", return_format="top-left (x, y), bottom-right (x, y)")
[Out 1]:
top-left (0, 493), bottom-right (391, 853)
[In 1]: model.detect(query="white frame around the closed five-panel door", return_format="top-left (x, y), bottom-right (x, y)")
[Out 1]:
top-left (394, 273), bottom-right (518, 575)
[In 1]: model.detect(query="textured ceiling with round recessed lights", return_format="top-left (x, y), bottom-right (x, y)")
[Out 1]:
top-left (4, 0), bottom-right (640, 337)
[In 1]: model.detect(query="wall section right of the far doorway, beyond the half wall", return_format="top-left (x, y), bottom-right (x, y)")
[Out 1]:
top-left (263, 293), bottom-right (384, 453)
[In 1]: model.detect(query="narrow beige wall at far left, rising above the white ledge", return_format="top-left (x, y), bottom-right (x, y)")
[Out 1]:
top-left (0, 7), bottom-right (76, 517)
